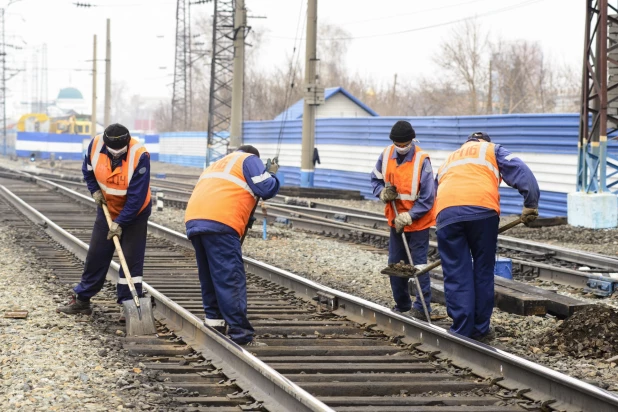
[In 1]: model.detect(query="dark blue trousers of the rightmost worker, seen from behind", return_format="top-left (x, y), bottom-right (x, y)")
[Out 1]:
top-left (437, 216), bottom-right (500, 338)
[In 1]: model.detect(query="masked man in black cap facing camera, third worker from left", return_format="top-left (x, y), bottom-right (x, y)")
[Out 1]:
top-left (371, 120), bottom-right (435, 320)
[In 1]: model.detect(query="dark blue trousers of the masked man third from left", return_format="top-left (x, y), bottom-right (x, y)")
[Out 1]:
top-left (388, 228), bottom-right (431, 312)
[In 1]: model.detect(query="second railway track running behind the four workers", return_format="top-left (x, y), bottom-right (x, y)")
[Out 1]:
top-left (6, 168), bottom-right (618, 296)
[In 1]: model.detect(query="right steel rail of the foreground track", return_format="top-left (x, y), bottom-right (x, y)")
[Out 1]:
top-left (12, 170), bottom-right (618, 412)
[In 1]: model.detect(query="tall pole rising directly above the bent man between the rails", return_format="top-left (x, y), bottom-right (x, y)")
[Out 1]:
top-left (228, 0), bottom-right (247, 152)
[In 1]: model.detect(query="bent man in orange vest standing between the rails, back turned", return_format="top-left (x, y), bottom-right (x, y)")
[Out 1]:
top-left (185, 145), bottom-right (279, 346)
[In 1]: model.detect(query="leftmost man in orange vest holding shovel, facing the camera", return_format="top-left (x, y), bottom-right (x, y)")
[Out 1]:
top-left (56, 123), bottom-right (151, 319)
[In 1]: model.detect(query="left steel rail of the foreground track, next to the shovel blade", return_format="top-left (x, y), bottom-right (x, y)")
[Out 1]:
top-left (0, 181), bottom-right (334, 412)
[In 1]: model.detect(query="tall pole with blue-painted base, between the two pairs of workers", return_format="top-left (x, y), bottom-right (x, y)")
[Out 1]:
top-left (300, 0), bottom-right (318, 187)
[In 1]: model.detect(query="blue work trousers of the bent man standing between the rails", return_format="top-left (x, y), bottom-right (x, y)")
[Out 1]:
top-left (191, 234), bottom-right (254, 345)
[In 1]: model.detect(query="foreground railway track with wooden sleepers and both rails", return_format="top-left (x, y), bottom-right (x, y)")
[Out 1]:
top-left (0, 171), bottom-right (618, 412)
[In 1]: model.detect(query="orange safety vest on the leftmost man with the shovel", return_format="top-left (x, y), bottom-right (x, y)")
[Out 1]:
top-left (90, 135), bottom-right (150, 220)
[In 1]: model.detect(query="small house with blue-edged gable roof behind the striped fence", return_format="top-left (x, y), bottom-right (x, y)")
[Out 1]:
top-left (275, 87), bottom-right (378, 120)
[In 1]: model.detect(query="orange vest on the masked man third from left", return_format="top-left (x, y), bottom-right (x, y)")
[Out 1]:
top-left (374, 145), bottom-right (436, 232)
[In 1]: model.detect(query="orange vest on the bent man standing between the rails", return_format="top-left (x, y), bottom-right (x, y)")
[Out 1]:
top-left (185, 152), bottom-right (258, 236)
